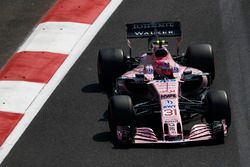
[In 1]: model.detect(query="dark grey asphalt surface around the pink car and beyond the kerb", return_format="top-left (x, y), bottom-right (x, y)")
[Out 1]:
top-left (0, 0), bottom-right (250, 167)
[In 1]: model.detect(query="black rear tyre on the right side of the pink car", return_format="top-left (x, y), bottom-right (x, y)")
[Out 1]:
top-left (185, 44), bottom-right (215, 82)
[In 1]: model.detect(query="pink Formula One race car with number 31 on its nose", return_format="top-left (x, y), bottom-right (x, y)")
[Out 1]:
top-left (98, 22), bottom-right (231, 145)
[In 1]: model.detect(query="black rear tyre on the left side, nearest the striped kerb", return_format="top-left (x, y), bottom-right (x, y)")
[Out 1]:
top-left (97, 48), bottom-right (125, 89)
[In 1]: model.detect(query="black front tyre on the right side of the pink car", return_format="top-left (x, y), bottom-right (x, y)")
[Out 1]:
top-left (205, 90), bottom-right (231, 128)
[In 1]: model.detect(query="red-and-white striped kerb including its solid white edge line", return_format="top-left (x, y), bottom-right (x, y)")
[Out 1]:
top-left (0, 0), bottom-right (122, 163)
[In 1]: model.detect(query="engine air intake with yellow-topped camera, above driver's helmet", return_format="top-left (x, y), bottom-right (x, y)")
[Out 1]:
top-left (152, 40), bottom-right (168, 58)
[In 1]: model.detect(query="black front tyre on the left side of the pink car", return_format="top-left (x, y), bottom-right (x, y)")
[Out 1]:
top-left (108, 95), bottom-right (135, 145)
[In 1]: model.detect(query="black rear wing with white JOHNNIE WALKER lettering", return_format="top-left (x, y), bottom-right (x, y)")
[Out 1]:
top-left (126, 21), bottom-right (181, 39)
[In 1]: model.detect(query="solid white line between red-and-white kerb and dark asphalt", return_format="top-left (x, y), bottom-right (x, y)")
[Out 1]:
top-left (0, 0), bottom-right (122, 163)
